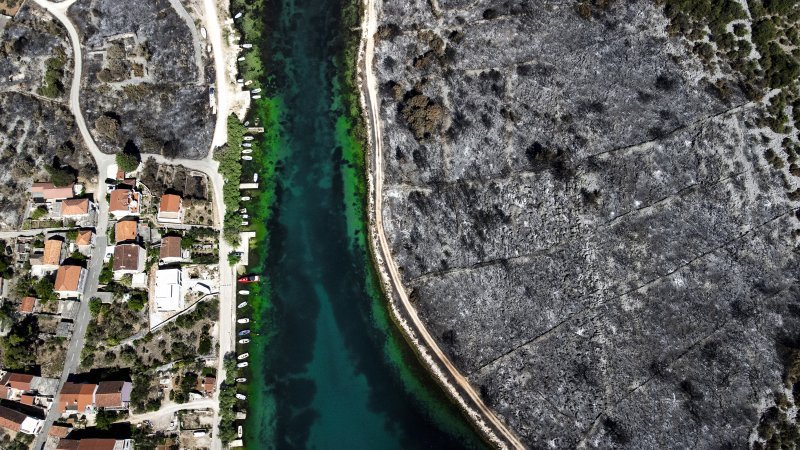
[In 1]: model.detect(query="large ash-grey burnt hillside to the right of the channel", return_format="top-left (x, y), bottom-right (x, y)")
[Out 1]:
top-left (375, 0), bottom-right (800, 449)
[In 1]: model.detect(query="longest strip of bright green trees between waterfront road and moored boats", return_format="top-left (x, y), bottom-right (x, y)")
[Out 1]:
top-left (214, 114), bottom-right (247, 245)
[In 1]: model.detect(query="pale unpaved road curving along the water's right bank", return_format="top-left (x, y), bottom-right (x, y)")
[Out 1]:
top-left (361, 0), bottom-right (525, 449)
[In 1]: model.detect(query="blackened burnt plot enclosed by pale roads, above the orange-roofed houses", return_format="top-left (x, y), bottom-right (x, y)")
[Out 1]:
top-left (69, 0), bottom-right (214, 159)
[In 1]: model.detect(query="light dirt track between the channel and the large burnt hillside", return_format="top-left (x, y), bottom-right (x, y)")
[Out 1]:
top-left (358, 0), bottom-right (525, 449)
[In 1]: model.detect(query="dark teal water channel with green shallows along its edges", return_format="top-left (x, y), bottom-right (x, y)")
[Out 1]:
top-left (239, 0), bottom-right (484, 449)
